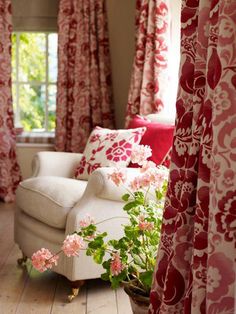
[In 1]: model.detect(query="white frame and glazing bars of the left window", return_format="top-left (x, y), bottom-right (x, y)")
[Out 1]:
top-left (12, 31), bottom-right (57, 133)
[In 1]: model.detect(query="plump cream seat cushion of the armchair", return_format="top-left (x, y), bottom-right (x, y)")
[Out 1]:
top-left (16, 176), bottom-right (87, 229)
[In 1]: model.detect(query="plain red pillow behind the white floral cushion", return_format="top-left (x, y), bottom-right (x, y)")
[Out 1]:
top-left (128, 116), bottom-right (174, 167)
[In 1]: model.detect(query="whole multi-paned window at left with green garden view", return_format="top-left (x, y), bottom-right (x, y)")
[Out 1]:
top-left (12, 32), bottom-right (57, 132)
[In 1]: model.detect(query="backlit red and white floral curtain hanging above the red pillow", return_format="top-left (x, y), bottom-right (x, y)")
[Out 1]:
top-left (126, 0), bottom-right (170, 125)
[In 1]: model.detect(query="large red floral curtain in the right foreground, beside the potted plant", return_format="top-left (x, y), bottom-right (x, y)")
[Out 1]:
top-left (149, 0), bottom-right (236, 314)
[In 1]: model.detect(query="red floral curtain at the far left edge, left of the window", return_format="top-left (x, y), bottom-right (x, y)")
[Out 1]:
top-left (0, 0), bottom-right (20, 202)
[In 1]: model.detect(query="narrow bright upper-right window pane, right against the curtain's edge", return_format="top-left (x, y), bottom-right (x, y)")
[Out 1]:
top-left (48, 34), bottom-right (57, 83)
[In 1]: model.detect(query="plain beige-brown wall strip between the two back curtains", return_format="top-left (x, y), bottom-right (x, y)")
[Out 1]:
top-left (106, 0), bottom-right (136, 128)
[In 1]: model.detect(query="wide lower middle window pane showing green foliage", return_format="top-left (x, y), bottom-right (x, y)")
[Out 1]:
top-left (19, 84), bottom-right (45, 131)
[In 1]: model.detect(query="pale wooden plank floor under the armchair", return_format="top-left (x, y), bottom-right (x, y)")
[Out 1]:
top-left (0, 202), bottom-right (132, 314)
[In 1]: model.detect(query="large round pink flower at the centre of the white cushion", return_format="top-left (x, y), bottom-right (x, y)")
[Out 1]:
top-left (106, 140), bottom-right (132, 162)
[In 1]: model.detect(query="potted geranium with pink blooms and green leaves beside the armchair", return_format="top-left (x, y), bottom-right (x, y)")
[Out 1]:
top-left (32, 145), bottom-right (168, 314)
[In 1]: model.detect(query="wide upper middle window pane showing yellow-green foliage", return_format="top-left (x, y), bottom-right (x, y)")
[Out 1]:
top-left (19, 33), bottom-right (46, 82)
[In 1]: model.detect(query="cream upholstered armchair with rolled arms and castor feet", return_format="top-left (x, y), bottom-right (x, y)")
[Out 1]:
top-left (15, 152), bottom-right (137, 296)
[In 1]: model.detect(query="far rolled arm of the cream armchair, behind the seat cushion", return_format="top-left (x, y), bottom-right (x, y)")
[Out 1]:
top-left (32, 152), bottom-right (82, 178)
